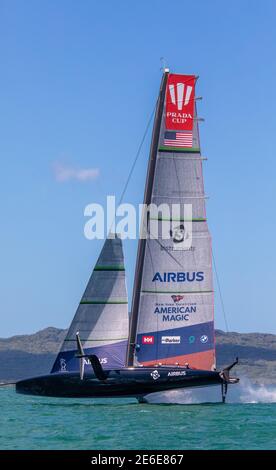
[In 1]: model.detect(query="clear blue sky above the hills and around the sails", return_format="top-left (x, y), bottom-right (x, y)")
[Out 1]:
top-left (0, 0), bottom-right (276, 337)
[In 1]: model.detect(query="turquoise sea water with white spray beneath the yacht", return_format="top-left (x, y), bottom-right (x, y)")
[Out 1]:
top-left (0, 383), bottom-right (276, 450)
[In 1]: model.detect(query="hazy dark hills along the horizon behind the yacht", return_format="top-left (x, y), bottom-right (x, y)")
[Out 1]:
top-left (0, 327), bottom-right (276, 384)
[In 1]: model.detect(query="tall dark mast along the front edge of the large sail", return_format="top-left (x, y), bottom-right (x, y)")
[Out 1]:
top-left (126, 68), bottom-right (169, 366)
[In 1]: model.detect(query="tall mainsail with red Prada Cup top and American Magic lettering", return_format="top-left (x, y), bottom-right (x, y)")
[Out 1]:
top-left (128, 70), bottom-right (215, 370)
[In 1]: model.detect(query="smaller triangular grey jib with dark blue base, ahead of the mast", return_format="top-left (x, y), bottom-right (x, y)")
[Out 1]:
top-left (52, 236), bottom-right (129, 373)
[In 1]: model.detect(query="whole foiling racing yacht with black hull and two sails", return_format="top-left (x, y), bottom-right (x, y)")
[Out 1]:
top-left (16, 69), bottom-right (239, 401)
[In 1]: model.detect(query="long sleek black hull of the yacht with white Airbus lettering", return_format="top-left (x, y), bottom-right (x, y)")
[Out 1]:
top-left (16, 367), bottom-right (223, 398)
